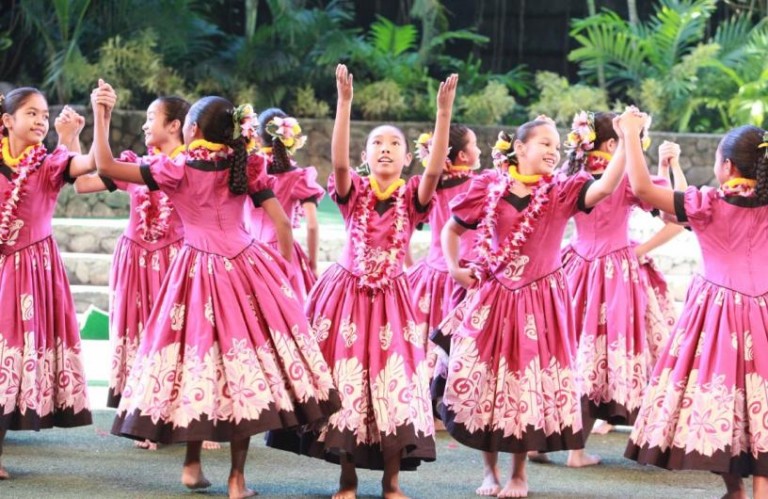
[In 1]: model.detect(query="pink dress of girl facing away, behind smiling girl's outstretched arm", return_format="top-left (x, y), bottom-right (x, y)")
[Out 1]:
top-left (563, 176), bottom-right (669, 424)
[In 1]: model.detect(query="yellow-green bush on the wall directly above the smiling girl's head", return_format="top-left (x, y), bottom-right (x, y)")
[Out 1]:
top-left (529, 71), bottom-right (609, 127)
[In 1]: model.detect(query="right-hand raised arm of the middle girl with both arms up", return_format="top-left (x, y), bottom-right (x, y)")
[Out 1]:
top-left (419, 74), bottom-right (459, 206)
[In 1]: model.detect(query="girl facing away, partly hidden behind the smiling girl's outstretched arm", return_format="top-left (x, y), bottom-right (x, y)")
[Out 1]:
top-left (563, 111), bottom-right (685, 460)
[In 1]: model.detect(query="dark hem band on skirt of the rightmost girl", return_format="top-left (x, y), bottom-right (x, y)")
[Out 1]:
top-left (624, 441), bottom-right (768, 477)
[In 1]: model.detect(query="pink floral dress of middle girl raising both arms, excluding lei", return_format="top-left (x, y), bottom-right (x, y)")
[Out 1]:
top-left (296, 173), bottom-right (435, 469)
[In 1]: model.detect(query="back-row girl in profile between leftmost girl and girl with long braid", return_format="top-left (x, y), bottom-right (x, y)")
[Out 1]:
top-left (75, 97), bottom-right (189, 414)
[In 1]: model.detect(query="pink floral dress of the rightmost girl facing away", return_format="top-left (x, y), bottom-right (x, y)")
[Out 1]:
top-left (626, 187), bottom-right (768, 476)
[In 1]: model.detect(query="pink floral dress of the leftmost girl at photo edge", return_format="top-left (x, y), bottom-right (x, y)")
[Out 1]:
top-left (0, 147), bottom-right (91, 430)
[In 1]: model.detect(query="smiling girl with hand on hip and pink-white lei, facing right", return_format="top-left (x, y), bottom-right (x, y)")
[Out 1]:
top-left (433, 114), bottom-right (623, 497)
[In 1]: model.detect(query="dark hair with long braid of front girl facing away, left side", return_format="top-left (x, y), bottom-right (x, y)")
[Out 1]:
top-left (187, 96), bottom-right (248, 194)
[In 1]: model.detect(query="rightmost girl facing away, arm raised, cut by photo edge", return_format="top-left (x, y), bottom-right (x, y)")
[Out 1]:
top-left (620, 115), bottom-right (768, 498)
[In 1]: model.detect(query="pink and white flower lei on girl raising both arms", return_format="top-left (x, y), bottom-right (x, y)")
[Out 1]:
top-left (350, 179), bottom-right (409, 291)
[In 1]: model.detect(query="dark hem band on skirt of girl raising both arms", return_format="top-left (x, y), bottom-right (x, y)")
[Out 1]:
top-left (267, 425), bottom-right (436, 471)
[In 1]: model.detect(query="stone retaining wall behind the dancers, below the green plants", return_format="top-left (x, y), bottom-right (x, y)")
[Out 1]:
top-left (48, 106), bottom-right (720, 218)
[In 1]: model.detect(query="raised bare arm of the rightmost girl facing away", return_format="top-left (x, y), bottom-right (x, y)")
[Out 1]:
top-left (617, 110), bottom-right (675, 214)
